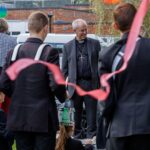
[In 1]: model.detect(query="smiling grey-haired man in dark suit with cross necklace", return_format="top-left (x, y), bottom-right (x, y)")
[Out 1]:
top-left (62, 19), bottom-right (101, 138)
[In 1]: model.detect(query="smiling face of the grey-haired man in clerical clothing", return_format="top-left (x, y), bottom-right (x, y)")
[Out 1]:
top-left (75, 24), bottom-right (87, 40)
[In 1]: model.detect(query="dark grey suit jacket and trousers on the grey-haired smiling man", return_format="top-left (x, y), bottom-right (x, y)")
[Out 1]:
top-left (62, 38), bottom-right (100, 138)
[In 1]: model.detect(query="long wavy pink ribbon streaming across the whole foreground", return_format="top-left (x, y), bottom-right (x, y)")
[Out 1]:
top-left (6, 0), bottom-right (150, 100)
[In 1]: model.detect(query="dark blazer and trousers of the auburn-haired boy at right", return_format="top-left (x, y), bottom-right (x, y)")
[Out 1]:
top-left (101, 34), bottom-right (150, 150)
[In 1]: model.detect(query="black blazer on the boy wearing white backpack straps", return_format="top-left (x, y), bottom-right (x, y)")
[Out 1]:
top-left (0, 38), bottom-right (65, 132)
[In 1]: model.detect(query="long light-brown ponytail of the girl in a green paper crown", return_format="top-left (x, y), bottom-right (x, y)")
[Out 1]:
top-left (55, 124), bottom-right (74, 150)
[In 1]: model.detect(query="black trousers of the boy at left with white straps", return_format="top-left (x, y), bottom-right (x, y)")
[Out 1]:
top-left (14, 131), bottom-right (56, 150)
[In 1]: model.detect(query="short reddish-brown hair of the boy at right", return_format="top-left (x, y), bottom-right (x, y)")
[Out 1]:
top-left (113, 3), bottom-right (137, 31)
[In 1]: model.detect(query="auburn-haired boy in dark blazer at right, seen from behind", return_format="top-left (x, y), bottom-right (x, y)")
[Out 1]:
top-left (100, 3), bottom-right (150, 150)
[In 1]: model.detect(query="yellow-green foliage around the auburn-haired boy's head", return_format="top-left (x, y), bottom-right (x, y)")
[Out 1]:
top-left (91, 0), bottom-right (150, 37)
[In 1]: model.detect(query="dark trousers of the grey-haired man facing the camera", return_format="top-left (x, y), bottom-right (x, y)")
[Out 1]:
top-left (72, 80), bottom-right (97, 138)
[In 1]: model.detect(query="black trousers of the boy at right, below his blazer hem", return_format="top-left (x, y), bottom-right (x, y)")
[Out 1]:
top-left (106, 134), bottom-right (150, 150)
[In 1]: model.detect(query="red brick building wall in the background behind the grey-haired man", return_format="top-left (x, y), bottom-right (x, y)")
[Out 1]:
top-left (6, 8), bottom-right (96, 33)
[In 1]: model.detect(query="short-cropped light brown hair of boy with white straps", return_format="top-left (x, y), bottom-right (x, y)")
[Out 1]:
top-left (28, 11), bottom-right (48, 33)
